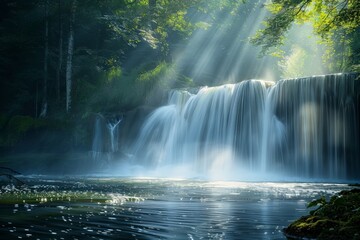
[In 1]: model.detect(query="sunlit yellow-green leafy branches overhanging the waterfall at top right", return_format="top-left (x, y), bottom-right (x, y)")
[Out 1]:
top-left (252, 0), bottom-right (360, 70)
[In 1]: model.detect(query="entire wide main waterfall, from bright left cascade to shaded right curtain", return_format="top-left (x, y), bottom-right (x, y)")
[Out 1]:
top-left (133, 74), bottom-right (360, 179)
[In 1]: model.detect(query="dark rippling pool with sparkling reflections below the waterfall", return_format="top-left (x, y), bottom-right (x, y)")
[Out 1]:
top-left (0, 177), bottom-right (347, 239)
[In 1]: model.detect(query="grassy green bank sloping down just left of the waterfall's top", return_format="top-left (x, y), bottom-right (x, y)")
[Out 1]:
top-left (86, 61), bottom-right (193, 112)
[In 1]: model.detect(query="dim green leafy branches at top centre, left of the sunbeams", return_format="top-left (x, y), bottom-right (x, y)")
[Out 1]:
top-left (103, 0), bottom-right (244, 55)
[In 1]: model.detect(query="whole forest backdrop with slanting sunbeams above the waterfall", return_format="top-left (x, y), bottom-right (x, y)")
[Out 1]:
top-left (0, 0), bottom-right (360, 119)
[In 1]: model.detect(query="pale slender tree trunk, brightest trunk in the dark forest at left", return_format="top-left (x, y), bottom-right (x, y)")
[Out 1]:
top-left (66, 0), bottom-right (76, 112)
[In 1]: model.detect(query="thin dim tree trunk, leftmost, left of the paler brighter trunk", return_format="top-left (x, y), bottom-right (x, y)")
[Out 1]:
top-left (40, 0), bottom-right (49, 118)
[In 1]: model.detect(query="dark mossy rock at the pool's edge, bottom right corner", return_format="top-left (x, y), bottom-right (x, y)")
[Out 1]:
top-left (284, 188), bottom-right (360, 239)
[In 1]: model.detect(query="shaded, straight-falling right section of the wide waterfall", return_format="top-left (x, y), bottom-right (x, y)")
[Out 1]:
top-left (262, 74), bottom-right (360, 179)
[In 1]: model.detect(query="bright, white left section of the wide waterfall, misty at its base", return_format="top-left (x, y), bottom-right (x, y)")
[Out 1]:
top-left (134, 80), bottom-right (267, 174)
